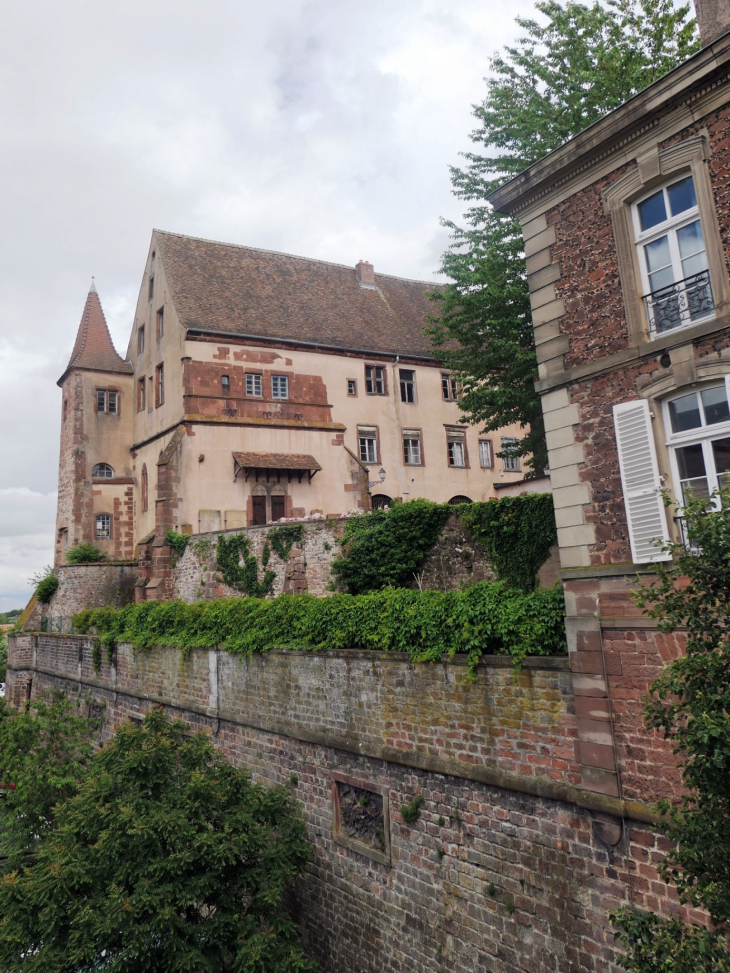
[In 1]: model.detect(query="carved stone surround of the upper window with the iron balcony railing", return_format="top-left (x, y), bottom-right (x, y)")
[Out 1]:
top-left (602, 133), bottom-right (730, 347)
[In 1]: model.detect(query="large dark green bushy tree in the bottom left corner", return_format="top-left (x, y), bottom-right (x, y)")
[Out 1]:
top-left (0, 710), bottom-right (314, 973)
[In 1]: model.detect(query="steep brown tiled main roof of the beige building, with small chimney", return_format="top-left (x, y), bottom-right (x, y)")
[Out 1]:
top-left (155, 230), bottom-right (438, 357)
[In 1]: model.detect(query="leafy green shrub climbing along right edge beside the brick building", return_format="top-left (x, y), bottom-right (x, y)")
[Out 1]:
top-left (611, 492), bottom-right (730, 973)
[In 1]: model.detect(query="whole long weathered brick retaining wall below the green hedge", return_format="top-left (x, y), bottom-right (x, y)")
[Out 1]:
top-left (11, 635), bottom-right (702, 973)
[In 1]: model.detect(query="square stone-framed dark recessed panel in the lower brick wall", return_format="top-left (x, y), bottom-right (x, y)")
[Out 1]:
top-left (332, 773), bottom-right (390, 865)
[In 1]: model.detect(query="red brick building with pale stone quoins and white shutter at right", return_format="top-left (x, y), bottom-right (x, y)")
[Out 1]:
top-left (491, 0), bottom-right (730, 800)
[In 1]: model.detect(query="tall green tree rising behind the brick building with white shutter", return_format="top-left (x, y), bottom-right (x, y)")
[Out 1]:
top-left (431, 0), bottom-right (699, 473)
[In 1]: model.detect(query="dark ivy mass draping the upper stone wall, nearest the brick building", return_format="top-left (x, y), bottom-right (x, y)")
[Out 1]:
top-left (332, 493), bottom-right (556, 595)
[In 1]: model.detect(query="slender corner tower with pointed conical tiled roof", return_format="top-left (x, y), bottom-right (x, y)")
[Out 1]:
top-left (55, 278), bottom-right (134, 564)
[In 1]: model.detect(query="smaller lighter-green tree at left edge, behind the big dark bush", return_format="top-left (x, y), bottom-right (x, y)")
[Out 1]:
top-left (0, 692), bottom-right (95, 864)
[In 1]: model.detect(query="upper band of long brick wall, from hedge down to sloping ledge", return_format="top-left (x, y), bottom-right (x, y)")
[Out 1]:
top-left (8, 633), bottom-right (657, 822)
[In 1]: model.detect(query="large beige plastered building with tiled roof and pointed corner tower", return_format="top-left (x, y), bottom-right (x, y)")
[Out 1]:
top-left (56, 231), bottom-right (522, 563)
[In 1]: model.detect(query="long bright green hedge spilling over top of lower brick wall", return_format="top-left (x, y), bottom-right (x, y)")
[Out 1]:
top-left (73, 582), bottom-right (566, 669)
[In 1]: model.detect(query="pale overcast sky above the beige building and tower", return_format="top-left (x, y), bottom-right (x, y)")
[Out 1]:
top-left (0, 0), bottom-right (533, 610)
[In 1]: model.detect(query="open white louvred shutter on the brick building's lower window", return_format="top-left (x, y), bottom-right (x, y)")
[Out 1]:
top-left (613, 399), bottom-right (671, 564)
